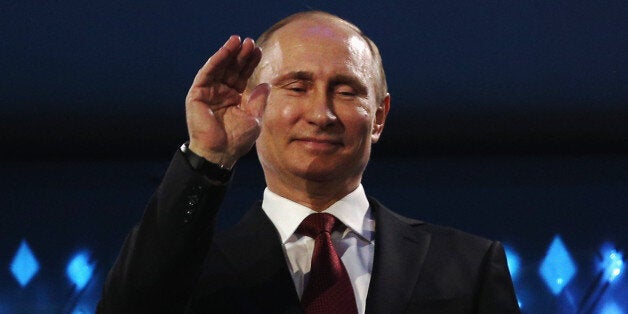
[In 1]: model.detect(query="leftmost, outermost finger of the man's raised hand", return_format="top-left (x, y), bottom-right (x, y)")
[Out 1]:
top-left (192, 35), bottom-right (241, 86)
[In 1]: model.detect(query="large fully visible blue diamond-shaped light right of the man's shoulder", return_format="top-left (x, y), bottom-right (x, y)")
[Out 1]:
top-left (539, 235), bottom-right (577, 295)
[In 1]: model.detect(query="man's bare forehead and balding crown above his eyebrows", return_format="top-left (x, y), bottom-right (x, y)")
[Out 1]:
top-left (262, 17), bottom-right (375, 76)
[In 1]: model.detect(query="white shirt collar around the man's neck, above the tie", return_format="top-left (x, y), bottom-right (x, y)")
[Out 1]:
top-left (262, 184), bottom-right (374, 243)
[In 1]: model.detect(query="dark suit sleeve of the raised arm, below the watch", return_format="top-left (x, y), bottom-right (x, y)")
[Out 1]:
top-left (97, 151), bottom-right (227, 313)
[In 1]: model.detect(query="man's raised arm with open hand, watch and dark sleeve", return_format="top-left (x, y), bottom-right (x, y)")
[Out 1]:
top-left (98, 36), bottom-right (262, 313)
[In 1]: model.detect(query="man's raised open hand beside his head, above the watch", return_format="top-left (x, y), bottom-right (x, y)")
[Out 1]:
top-left (185, 35), bottom-right (270, 168)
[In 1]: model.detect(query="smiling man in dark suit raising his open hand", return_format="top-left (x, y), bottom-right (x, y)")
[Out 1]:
top-left (98, 12), bottom-right (518, 313)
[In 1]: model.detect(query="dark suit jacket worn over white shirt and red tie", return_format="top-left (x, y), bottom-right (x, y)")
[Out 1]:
top-left (98, 153), bottom-right (519, 313)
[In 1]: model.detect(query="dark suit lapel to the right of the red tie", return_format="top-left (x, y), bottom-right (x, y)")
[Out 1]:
top-left (366, 199), bottom-right (430, 313)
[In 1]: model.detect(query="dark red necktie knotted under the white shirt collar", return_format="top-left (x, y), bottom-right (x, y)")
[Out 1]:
top-left (297, 213), bottom-right (358, 314)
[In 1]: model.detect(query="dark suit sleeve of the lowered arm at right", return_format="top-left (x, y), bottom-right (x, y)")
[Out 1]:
top-left (478, 241), bottom-right (520, 313)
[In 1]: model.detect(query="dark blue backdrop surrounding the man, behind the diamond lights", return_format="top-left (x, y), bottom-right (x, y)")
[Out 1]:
top-left (0, 0), bottom-right (628, 313)
